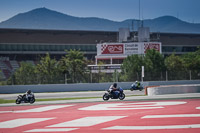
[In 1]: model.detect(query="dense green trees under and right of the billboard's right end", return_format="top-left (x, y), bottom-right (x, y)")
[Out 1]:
top-left (121, 49), bottom-right (200, 81)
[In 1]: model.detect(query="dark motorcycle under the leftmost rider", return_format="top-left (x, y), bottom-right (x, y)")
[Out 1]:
top-left (15, 94), bottom-right (35, 104)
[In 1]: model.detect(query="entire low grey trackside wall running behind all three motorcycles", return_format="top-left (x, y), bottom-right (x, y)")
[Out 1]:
top-left (0, 80), bottom-right (200, 94)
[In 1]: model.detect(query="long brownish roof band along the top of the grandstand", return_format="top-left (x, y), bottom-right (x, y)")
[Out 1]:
top-left (0, 29), bottom-right (200, 46)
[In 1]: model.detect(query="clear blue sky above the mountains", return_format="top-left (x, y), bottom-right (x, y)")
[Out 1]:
top-left (0, 0), bottom-right (200, 23)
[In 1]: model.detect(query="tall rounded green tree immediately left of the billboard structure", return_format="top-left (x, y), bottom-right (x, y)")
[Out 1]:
top-left (61, 50), bottom-right (87, 83)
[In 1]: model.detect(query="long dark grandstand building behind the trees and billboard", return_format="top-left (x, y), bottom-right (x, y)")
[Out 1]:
top-left (0, 29), bottom-right (200, 79)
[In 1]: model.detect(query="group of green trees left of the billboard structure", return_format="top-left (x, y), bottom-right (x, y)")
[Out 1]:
top-left (6, 50), bottom-right (87, 85)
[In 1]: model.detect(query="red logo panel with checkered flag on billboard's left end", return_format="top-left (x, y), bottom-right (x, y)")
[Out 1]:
top-left (101, 44), bottom-right (124, 54)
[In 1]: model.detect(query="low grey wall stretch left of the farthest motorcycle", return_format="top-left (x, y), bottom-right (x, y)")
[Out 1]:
top-left (0, 82), bottom-right (136, 94)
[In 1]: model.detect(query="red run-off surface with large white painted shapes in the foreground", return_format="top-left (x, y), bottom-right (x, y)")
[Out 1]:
top-left (0, 93), bottom-right (200, 133)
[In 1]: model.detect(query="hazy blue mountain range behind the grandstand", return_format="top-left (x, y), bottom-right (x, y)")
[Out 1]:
top-left (0, 8), bottom-right (200, 33)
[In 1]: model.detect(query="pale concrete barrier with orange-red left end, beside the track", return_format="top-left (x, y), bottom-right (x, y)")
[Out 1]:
top-left (147, 84), bottom-right (200, 96)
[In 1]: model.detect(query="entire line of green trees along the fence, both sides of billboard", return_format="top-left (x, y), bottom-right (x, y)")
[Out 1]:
top-left (1, 49), bottom-right (200, 85)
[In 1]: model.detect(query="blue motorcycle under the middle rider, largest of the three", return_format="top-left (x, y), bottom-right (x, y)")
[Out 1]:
top-left (103, 87), bottom-right (125, 101)
